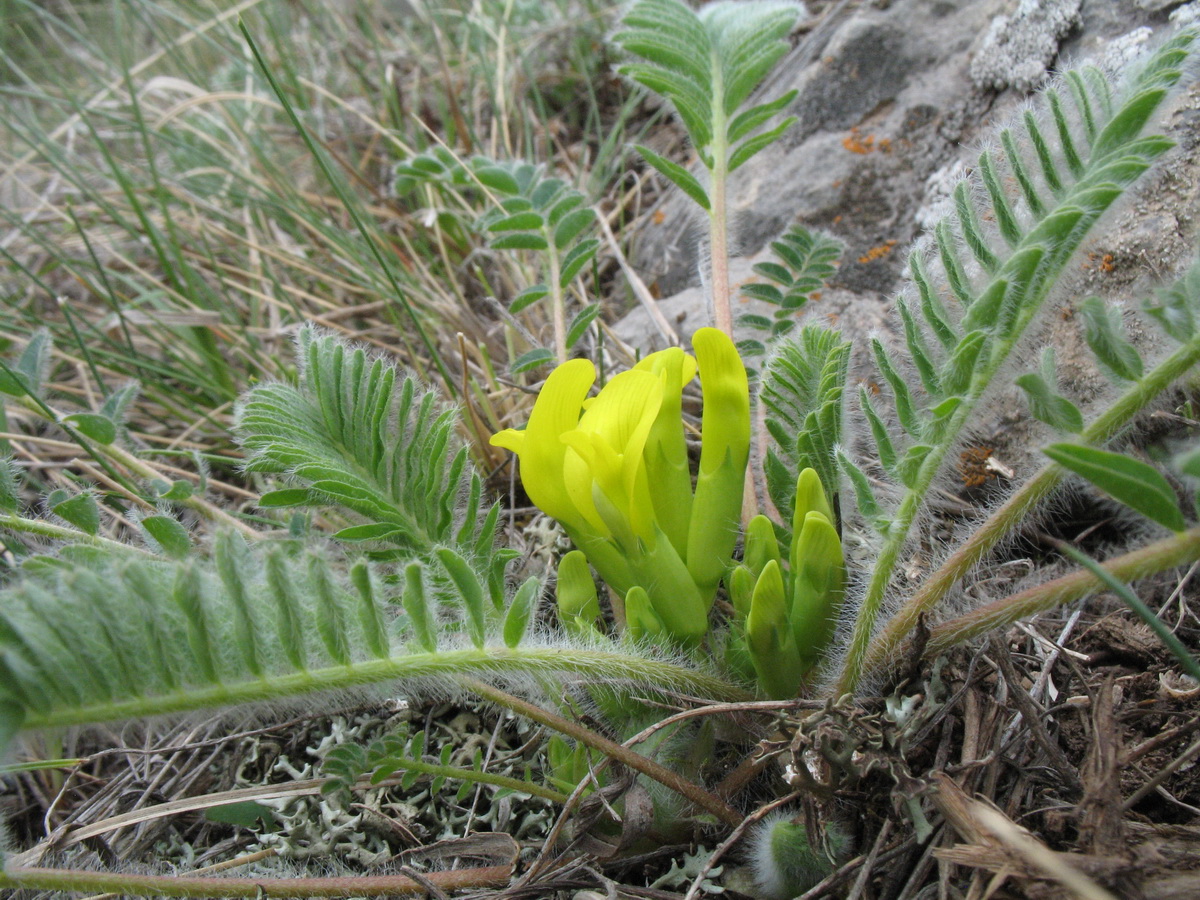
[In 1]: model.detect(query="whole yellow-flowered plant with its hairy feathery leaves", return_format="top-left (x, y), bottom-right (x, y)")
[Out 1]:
top-left (0, 7), bottom-right (1200, 890)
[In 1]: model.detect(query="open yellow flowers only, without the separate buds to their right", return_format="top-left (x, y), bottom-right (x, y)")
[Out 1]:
top-left (492, 328), bottom-right (750, 647)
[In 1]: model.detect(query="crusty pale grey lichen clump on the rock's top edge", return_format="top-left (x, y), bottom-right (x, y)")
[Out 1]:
top-left (971, 0), bottom-right (1082, 91)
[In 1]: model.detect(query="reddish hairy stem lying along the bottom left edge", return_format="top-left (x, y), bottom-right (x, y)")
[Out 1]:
top-left (0, 865), bottom-right (512, 898)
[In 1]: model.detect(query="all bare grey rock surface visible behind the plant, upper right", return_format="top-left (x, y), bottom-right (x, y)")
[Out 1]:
top-left (617, 0), bottom-right (1200, 367)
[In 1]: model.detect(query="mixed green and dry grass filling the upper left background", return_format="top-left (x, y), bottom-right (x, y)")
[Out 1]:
top-left (0, 0), bottom-right (652, 480)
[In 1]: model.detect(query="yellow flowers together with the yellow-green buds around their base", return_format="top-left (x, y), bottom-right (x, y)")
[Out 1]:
top-left (492, 328), bottom-right (845, 697)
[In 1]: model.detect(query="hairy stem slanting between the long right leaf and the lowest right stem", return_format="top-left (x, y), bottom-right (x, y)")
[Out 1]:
top-left (864, 338), bottom-right (1200, 671)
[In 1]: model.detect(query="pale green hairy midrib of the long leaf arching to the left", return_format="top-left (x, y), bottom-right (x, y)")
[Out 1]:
top-left (23, 647), bottom-right (748, 728)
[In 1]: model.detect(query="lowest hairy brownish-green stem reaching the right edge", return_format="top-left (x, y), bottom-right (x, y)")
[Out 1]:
top-left (925, 528), bottom-right (1200, 656)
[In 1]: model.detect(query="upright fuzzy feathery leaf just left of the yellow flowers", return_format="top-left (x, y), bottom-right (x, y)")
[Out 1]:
top-left (236, 326), bottom-right (491, 566)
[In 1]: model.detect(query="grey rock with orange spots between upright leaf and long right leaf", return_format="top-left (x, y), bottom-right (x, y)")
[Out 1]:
top-left (634, 0), bottom-right (1003, 303)
